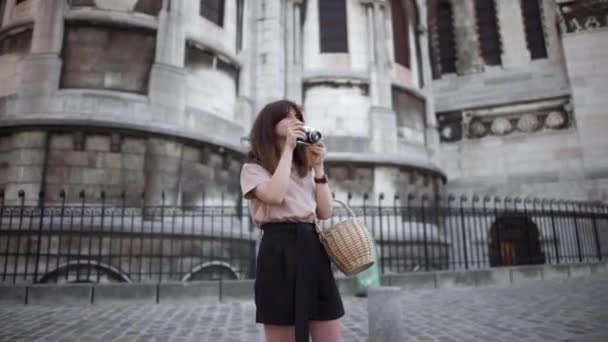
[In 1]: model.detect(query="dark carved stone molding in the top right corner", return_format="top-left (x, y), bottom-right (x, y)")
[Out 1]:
top-left (558, 0), bottom-right (608, 34)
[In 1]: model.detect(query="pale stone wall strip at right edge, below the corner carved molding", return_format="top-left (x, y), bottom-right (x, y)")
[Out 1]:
top-left (562, 1), bottom-right (608, 201)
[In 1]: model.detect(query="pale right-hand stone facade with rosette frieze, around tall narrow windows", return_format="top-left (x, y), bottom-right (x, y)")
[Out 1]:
top-left (433, 0), bottom-right (608, 201)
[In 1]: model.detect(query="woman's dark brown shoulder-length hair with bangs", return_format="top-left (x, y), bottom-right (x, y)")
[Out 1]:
top-left (247, 100), bottom-right (311, 177)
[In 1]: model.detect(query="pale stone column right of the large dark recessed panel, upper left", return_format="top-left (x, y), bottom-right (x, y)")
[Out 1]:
top-left (149, 1), bottom-right (186, 113)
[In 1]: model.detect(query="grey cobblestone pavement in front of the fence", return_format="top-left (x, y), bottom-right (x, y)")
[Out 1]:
top-left (0, 275), bottom-right (608, 342)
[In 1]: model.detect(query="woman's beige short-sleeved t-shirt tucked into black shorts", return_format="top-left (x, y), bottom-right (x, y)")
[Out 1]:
top-left (241, 163), bottom-right (317, 226)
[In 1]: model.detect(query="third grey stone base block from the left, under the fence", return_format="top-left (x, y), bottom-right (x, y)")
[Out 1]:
top-left (93, 283), bottom-right (158, 305)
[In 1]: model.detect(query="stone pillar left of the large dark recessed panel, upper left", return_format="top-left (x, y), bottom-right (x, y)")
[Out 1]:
top-left (19, 0), bottom-right (65, 97)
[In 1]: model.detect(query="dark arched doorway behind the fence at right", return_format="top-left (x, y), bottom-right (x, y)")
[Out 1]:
top-left (489, 215), bottom-right (545, 267)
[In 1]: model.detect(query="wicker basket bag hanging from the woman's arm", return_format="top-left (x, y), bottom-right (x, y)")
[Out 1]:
top-left (317, 199), bottom-right (374, 276)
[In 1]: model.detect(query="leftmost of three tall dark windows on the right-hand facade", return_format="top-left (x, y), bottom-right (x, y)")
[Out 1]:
top-left (431, 0), bottom-right (456, 77)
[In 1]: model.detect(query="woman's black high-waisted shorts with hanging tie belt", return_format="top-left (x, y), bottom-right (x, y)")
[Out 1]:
top-left (255, 222), bottom-right (344, 340)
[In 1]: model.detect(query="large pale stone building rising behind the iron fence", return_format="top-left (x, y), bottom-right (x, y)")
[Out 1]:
top-left (0, 0), bottom-right (608, 278)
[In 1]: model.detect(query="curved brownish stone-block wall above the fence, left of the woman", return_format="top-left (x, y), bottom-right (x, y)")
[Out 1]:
top-left (0, 130), bottom-right (242, 206)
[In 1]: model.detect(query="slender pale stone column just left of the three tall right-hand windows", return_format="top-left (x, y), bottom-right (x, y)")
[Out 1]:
top-left (416, 0), bottom-right (439, 162)
